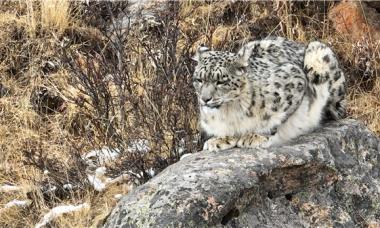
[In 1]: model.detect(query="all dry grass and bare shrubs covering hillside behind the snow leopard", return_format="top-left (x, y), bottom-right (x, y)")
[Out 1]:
top-left (0, 0), bottom-right (380, 227)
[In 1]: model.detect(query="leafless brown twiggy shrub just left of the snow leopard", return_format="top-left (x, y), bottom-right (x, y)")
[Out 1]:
top-left (62, 2), bottom-right (197, 182)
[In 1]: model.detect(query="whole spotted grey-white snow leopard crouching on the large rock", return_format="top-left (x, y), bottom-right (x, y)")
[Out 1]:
top-left (192, 37), bottom-right (346, 151)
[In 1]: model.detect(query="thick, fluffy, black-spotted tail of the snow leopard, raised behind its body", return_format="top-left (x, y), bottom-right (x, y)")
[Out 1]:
top-left (304, 41), bottom-right (346, 120)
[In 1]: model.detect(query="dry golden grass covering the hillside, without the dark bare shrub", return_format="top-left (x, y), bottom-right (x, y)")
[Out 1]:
top-left (0, 0), bottom-right (380, 227)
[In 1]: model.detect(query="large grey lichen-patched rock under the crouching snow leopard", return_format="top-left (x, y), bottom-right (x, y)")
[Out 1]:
top-left (104, 120), bottom-right (380, 227)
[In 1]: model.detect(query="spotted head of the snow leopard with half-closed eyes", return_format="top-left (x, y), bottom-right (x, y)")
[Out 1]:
top-left (193, 47), bottom-right (249, 109)
